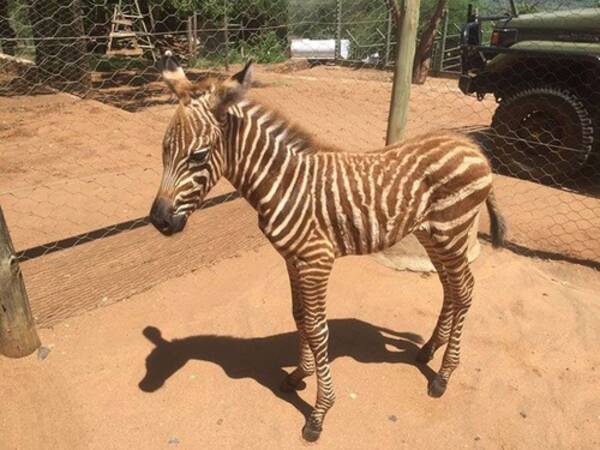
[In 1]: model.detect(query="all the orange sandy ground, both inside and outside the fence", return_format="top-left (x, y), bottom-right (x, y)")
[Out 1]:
top-left (0, 63), bottom-right (600, 449)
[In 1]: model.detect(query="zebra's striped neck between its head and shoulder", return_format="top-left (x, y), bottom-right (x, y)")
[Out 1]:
top-left (224, 101), bottom-right (316, 212)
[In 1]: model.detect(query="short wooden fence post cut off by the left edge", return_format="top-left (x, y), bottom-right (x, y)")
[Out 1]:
top-left (0, 208), bottom-right (40, 358)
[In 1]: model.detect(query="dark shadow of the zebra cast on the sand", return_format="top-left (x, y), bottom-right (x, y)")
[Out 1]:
top-left (139, 319), bottom-right (435, 416)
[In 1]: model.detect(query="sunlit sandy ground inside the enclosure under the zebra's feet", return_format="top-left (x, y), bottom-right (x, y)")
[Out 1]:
top-left (0, 237), bottom-right (600, 449)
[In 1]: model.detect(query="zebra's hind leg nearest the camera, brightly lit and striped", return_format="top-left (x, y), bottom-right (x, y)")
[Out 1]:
top-left (428, 235), bottom-right (474, 397)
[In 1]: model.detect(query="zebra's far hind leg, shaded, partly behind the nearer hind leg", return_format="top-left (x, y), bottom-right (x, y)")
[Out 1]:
top-left (415, 233), bottom-right (453, 364)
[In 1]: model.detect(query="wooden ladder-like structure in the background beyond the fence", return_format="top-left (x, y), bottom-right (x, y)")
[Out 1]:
top-left (106, 0), bottom-right (156, 61)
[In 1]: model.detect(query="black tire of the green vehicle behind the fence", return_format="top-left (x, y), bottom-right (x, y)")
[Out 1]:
top-left (491, 87), bottom-right (594, 183)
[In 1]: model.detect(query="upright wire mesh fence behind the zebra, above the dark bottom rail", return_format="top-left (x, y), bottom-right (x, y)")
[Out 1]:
top-left (0, 0), bottom-right (600, 292)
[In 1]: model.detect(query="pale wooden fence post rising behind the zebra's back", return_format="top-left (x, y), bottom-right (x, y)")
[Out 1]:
top-left (386, 0), bottom-right (420, 145)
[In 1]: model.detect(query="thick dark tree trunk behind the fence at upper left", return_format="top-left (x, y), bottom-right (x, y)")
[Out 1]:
top-left (29, 0), bottom-right (91, 93)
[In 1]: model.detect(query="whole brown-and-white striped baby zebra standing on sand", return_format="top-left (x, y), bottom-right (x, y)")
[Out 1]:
top-left (150, 52), bottom-right (505, 441)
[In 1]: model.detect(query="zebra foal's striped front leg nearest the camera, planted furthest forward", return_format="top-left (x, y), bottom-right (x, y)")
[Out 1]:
top-left (294, 253), bottom-right (335, 442)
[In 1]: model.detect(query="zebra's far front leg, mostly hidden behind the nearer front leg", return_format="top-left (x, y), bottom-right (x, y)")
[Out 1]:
top-left (281, 260), bottom-right (315, 392)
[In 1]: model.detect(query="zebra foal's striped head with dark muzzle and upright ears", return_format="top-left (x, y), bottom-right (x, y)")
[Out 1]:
top-left (150, 52), bottom-right (252, 236)
